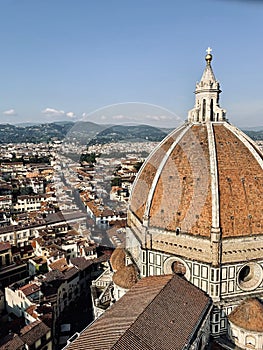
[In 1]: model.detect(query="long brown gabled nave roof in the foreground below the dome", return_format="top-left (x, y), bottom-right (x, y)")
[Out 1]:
top-left (67, 275), bottom-right (212, 350)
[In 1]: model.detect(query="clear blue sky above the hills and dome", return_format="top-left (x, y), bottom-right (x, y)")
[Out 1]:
top-left (0, 0), bottom-right (263, 127)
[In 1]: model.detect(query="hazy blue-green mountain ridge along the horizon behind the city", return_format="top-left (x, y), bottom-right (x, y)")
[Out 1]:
top-left (0, 121), bottom-right (263, 145)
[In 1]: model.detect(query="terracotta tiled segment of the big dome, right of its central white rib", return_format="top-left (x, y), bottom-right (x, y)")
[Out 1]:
top-left (214, 125), bottom-right (263, 237)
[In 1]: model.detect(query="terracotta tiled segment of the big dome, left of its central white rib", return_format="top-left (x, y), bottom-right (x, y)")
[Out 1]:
top-left (150, 125), bottom-right (212, 237)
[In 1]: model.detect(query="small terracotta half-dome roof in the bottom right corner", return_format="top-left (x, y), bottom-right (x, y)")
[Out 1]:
top-left (228, 298), bottom-right (263, 333)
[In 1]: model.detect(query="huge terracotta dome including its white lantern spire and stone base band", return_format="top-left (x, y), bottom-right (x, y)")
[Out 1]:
top-left (128, 52), bottom-right (263, 265)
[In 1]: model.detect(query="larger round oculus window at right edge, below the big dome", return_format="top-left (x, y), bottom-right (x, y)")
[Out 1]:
top-left (237, 262), bottom-right (263, 291)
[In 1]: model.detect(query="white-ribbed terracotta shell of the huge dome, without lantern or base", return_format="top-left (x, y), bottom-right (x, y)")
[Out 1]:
top-left (130, 122), bottom-right (263, 238)
